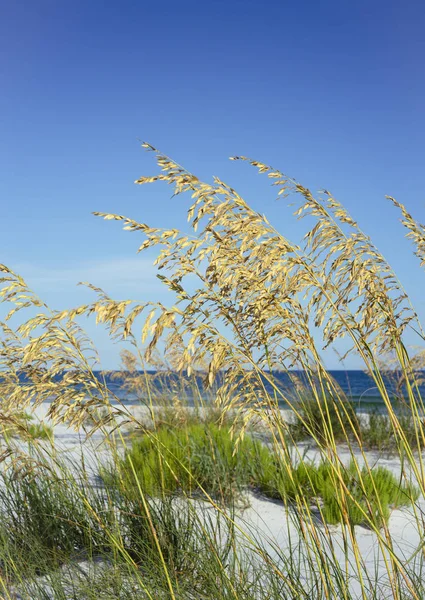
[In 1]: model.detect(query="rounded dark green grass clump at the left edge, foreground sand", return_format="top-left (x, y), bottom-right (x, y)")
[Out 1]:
top-left (0, 465), bottom-right (113, 572)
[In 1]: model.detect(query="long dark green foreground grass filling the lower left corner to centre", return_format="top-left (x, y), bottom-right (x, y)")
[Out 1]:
top-left (0, 452), bottom-right (301, 600)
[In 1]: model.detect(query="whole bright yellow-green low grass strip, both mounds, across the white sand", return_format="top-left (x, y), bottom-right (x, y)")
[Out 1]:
top-left (113, 424), bottom-right (419, 528)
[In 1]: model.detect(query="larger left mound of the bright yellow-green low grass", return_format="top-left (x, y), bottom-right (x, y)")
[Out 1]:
top-left (114, 422), bottom-right (270, 501)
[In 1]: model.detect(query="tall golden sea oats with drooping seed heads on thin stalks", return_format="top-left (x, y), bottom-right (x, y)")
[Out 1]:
top-left (1, 143), bottom-right (425, 599)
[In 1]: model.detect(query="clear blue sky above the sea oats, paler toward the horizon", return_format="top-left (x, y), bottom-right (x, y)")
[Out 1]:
top-left (0, 0), bottom-right (425, 368)
